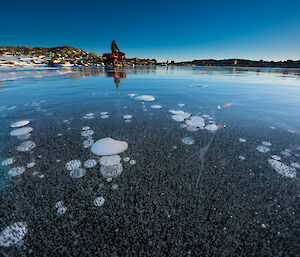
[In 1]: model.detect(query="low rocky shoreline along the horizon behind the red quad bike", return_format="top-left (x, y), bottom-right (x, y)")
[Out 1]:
top-left (0, 46), bottom-right (300, 68)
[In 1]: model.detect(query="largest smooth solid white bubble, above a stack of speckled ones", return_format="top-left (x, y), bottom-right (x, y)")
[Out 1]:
top-left (91, 137), bottom-right (128, 156)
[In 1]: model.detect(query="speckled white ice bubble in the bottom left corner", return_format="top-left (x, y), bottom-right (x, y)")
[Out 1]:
top-left (0, 222), bottom-right (28, 247)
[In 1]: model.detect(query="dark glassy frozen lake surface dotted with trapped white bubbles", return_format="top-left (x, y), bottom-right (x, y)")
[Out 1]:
top-left (0, 66), bottom-right (300, 256)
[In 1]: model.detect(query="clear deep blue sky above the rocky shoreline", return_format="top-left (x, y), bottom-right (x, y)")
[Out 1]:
top-left (0, 0), bottom-right (300, 60)
